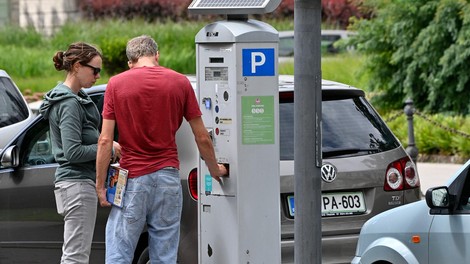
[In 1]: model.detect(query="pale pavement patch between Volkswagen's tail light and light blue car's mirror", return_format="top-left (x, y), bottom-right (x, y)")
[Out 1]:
top-left (416, 162), bottom-right (463, 194)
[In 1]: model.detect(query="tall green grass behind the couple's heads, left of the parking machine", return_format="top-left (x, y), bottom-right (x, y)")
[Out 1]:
top-left (0, 19), bottom-right (206, 92)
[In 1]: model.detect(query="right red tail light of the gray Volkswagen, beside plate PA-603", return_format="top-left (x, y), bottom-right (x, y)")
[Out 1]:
top-left (384, 157), bottom-right (420, 191)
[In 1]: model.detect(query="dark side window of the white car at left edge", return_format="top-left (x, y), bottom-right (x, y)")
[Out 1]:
top-left (0, 78), bottom-right (29, 128)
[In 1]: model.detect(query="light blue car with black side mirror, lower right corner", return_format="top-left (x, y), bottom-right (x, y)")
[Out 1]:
top-left (351, 160), bottom-right (470, 264)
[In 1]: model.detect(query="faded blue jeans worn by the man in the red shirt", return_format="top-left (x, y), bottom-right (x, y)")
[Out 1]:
top-left (106, 168), bottom-right (183, 264)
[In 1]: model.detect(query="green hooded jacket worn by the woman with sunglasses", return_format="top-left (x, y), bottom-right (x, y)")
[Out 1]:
top-left (39, 84), bottom-right (101, 182)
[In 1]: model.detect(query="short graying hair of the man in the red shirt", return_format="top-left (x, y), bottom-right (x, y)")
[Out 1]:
top-left (126, 35), bottom-right (158, 63)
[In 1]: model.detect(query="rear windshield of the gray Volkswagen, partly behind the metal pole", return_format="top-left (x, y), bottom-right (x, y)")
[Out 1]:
top-left (279, 97), bottom-right (400, 160)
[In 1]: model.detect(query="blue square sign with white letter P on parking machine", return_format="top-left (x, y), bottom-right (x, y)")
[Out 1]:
top-left (242, 49), bottom-right (274, 76)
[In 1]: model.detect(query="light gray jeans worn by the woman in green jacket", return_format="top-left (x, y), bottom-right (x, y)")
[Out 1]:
top-left (54, 180), bottom-right (98, 264)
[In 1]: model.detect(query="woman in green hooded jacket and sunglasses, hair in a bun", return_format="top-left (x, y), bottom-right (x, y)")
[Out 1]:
top-left (40, 42), bottom-right (120, 263)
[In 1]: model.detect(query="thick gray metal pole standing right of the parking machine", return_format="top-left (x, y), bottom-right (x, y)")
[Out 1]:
top-left (294, 0), bottom-right (322, 264)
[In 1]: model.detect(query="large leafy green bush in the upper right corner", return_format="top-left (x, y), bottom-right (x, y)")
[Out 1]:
top-left (350, 0), bottom-right (470, 115)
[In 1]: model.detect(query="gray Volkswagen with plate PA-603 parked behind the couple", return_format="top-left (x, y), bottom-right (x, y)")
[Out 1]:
top-left (0, 76), bottom-right (421, 264)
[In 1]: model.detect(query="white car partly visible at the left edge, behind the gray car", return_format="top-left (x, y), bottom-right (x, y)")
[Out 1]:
top-left (0, 69), bottom-right (34, 150)
